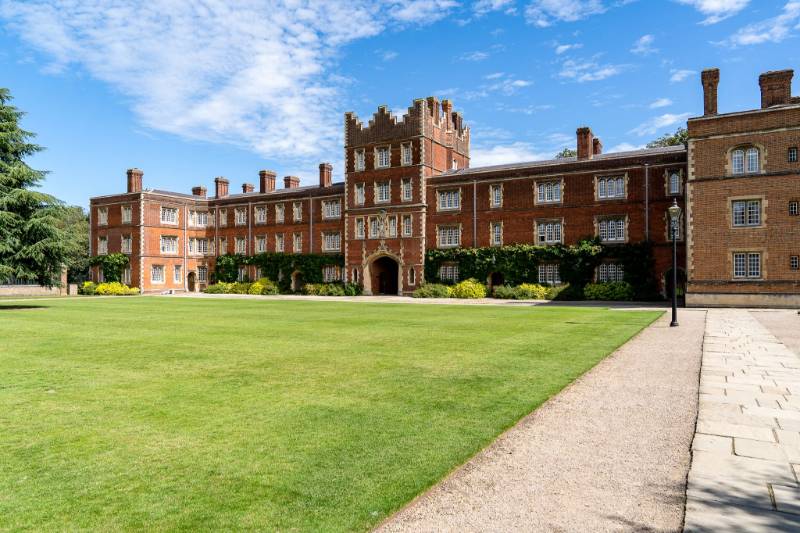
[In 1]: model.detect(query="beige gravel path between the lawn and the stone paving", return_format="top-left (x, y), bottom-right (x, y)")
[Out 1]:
top-left (378, 310), bottom-right (706, 532)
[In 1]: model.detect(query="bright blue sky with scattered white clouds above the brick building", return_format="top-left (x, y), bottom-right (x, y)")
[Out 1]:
top-left (0, 0), bottom-right (800, 205)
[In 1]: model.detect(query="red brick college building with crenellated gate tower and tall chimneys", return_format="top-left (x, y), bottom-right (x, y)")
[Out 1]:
top-left (90, 71), bottom-right (800, 305)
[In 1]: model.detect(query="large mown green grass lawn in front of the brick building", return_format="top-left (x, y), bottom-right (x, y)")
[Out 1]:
top-left (0, 297), bottom-right (661, 531)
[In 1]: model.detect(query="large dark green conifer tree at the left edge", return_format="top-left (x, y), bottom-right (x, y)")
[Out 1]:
top-left (0, 88), bottom-right (66, 287)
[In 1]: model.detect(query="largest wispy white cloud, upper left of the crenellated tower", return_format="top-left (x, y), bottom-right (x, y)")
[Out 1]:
top-left (0, 0), bottom-right (457, 180)
